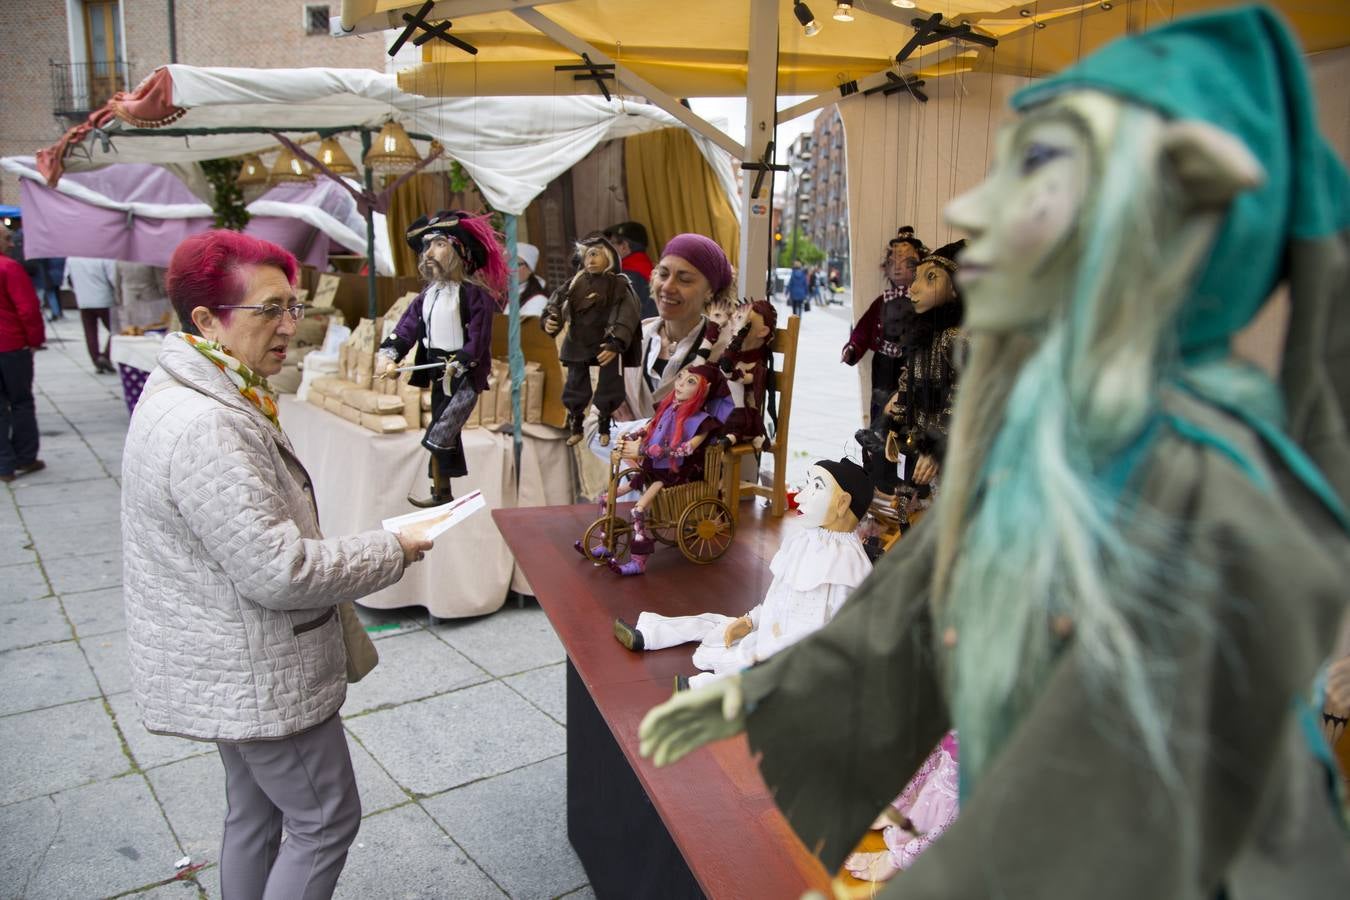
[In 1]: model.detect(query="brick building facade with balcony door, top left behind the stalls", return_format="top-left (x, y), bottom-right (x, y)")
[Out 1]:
top-left (0, 0), bottom-right (389, 204)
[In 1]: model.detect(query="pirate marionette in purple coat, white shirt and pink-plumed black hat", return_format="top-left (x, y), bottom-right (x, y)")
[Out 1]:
top-left (377, 209), bottom-right (508, 506)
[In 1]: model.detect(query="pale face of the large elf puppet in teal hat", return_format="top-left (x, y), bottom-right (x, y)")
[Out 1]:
top-left (946, 99), bottom-right (1090, 331)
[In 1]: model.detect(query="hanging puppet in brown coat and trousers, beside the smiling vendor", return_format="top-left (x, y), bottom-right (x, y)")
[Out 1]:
top-left (540, 236), bottom-right (643, 447)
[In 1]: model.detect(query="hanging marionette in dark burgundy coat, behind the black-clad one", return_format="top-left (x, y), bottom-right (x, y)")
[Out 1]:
top-left (841, 225), bottom-right (927, 422)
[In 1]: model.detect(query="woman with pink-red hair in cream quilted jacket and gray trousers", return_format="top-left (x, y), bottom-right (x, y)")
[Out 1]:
top-left (122, 231), bottom-right (431, 899)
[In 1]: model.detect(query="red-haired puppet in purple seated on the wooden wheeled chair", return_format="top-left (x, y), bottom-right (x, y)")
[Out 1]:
top-left (609, 363), bottom-right (726, 575)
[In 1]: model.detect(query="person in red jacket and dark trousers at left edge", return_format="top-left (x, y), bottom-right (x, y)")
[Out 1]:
top-left (0, 228), bottom-right (46, 482)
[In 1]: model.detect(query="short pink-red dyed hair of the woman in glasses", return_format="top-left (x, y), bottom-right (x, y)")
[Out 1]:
top-left (165, 231), bottom-right (300, 333)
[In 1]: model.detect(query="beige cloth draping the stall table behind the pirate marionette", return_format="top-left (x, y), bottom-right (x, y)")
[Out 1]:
top-left (279, 395), bottom-right (575, 618)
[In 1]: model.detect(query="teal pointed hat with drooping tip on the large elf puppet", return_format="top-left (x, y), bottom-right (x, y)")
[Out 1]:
top-left (1013, 7), bottom-right (1350, 358)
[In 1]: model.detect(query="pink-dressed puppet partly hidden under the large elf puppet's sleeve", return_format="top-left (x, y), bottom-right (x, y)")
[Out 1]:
top-left (844, 731), bottom-right (960, 881)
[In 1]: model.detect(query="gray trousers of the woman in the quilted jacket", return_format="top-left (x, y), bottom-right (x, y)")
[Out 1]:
top-left (216, 715), bottom-right (360, 900)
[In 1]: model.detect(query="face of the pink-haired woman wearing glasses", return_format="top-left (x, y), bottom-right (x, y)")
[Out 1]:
top-left (192, 266), bottom-right (297, 378)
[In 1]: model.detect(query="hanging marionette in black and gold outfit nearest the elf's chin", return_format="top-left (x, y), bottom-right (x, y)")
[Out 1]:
top-left (855, 240), bottom-right (965, 526)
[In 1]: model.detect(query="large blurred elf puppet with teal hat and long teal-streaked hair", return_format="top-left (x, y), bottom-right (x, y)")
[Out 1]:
top-left (640, 8), bottom-right (1350, 900)
